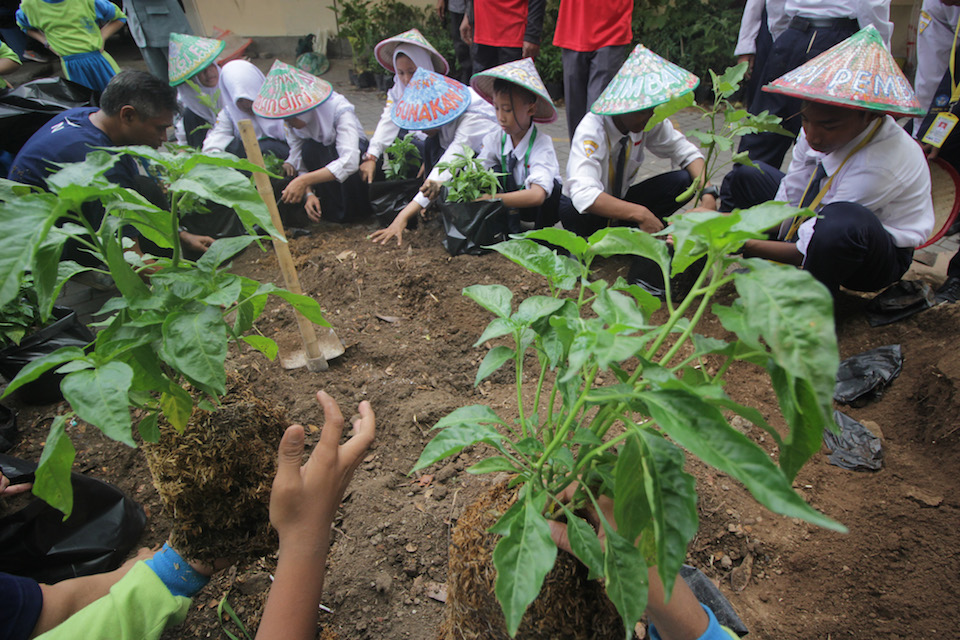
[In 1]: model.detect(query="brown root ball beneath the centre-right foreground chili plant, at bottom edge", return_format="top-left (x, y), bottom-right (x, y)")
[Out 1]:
top-left (439, 482), bottom-right (624, 640)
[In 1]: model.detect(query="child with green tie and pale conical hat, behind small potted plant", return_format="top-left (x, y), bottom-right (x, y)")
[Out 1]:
top-left (470, 58), bottom-right (561, 233)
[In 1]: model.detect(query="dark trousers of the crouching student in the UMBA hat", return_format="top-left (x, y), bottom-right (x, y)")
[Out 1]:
top-left (560, 169), bottom-right (693, 238)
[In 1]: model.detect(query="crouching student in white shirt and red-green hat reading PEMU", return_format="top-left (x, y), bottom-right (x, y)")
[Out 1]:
top-left (722, 26), bottom-right (934, 292)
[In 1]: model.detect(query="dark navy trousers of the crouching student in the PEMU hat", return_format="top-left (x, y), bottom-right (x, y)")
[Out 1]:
top-left (720, 165), bottom-right (913, 292)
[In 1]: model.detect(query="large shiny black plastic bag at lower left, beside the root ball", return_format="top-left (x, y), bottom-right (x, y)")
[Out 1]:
top-left (0, 454), bottom-right (147, 583)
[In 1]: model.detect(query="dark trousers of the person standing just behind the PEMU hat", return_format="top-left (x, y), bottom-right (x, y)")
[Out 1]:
top-left (739, 21), bottom-right (857, 168)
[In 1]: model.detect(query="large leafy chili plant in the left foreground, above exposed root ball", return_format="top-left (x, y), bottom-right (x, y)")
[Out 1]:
top-left (0, 147), bottom-right (327, 515)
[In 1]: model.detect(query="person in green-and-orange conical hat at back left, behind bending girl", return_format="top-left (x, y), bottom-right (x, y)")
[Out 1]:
top-left (167, 33), bottom-right (225, 147)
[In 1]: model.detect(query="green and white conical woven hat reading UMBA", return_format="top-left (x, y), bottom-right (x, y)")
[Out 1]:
top-left (590, 44), bottom-right (700, 116)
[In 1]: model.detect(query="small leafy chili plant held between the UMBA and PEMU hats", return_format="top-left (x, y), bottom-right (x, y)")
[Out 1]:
top-left (645, 62), bottom-right (793, 202)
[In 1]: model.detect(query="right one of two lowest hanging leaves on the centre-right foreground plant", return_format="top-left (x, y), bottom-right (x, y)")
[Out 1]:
top-left (598, 511), bottom-right (647, 639)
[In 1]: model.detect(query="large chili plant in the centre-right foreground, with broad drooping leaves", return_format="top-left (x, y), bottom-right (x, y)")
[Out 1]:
top-left (414, 212), bottom-right (844, 635)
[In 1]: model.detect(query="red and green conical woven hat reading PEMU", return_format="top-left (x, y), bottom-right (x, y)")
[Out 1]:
top-left (763, 25), bottom-right (926, 116)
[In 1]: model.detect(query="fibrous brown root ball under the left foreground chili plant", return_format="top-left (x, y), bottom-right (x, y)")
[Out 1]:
top-left (143, 376), bottom-right (289, 562)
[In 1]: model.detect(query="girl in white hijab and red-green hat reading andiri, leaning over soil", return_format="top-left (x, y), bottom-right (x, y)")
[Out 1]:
top-left (253, 60), bottom-right (370, 222)
